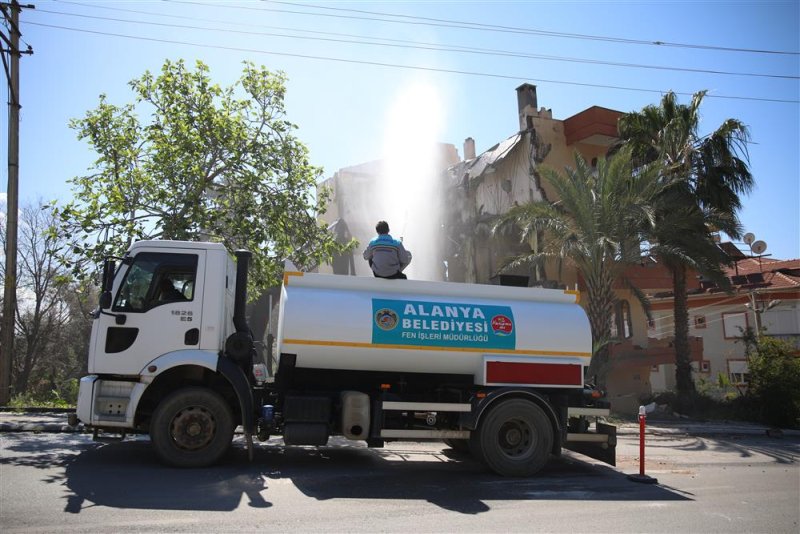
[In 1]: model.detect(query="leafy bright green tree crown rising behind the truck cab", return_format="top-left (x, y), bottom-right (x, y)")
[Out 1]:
top-left (54, 61), bottom-right (354, 296)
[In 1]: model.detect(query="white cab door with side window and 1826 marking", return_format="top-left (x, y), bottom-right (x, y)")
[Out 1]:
top-left (90, 249), bottom-right (206, 375)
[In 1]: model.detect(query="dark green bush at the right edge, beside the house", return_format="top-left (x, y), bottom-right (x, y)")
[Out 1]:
top-left (747, 336), bottom-right (800, 428)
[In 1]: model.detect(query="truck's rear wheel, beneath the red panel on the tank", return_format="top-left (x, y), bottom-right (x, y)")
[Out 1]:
top-left (470, 399), bottom-right (553, 477)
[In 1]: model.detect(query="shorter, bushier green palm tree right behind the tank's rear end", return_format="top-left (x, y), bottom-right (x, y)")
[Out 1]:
top-left (493, 149), bottom-right (664, 387)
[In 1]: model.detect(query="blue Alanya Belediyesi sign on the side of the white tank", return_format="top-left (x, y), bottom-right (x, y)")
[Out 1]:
top-left (372, 299), bottom-right (516, 350)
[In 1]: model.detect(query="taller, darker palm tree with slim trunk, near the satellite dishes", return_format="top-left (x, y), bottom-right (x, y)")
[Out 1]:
top-left (619, 91), bottom-right (754, 393)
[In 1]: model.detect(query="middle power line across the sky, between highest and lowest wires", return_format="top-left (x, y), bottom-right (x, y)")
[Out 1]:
top-left (34, 2), bottom-right (800, 80)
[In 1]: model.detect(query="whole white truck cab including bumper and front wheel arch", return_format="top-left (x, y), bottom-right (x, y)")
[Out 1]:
top-left (77, 240), bottom-right (252, 464)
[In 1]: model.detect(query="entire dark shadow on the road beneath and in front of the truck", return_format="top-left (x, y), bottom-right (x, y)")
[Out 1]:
top-left (0, 436), bottom-right (689, 514)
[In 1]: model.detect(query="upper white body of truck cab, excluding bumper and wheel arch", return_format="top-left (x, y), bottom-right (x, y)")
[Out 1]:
top-left (88, 241), bottom-right (235, 376)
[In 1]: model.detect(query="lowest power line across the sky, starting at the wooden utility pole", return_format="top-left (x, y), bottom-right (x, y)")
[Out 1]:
top-left (28, 22), bottom-right (800, 104)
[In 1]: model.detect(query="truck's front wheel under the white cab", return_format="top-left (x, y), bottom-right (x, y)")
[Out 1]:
top-left (150, 388), bottom-right (234, 467)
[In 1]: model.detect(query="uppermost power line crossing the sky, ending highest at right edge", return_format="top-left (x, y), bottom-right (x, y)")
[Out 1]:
top-left (163, 0), bottom-right (800, 55)
